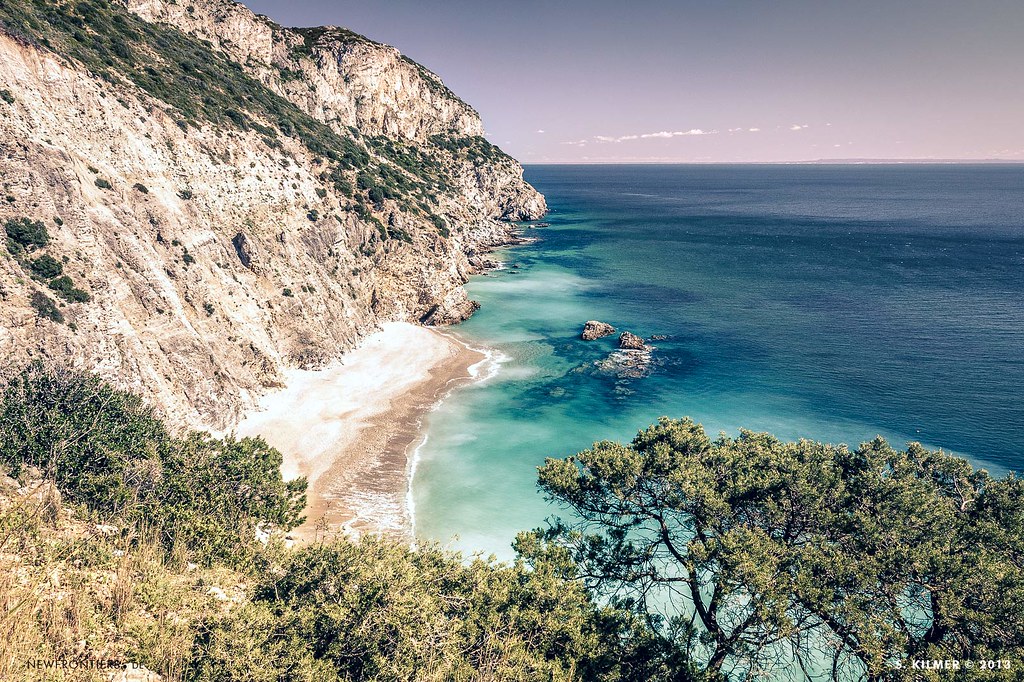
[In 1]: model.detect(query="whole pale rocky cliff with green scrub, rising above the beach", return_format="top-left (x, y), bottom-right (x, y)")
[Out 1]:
top-left (0, 0), bottom-right (545, 428)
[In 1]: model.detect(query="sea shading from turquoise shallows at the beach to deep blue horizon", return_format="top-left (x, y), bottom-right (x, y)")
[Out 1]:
top-left (413, 165), bottom-right (1024, 558)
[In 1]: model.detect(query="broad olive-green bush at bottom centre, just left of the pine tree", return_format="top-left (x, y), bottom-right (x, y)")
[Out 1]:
top-left (193, 539), bottom-right (625, 682)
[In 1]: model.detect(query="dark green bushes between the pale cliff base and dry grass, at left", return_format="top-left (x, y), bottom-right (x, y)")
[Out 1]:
top-left (0, 363), bottom-right (305, 560)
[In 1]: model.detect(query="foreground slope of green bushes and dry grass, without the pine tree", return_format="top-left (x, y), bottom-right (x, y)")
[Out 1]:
top-left (0, 364), bottom-right (682, 682)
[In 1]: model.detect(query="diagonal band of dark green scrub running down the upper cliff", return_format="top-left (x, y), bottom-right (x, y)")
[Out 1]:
top-left (0, 0), bottom-right (524, 239)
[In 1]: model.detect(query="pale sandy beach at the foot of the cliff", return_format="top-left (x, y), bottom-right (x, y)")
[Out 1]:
top-left (236, 323), bottom-right (486, 540)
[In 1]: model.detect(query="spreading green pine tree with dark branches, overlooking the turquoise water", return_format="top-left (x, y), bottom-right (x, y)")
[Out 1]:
top-left (536, 418), bottom-right (1024, 680)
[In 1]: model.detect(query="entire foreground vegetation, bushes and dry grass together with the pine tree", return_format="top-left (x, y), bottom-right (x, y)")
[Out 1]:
top-left (0, 365), bottom-right (1024, 682)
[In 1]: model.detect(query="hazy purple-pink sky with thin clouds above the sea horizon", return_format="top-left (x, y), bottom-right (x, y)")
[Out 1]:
top-left (244, 0), bottom-right (1024, 163)
